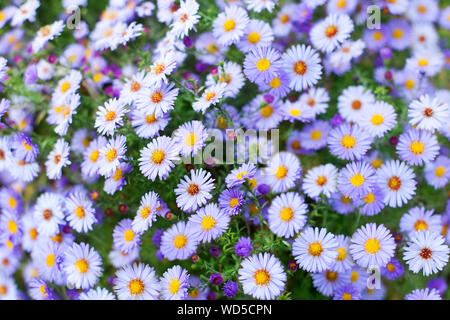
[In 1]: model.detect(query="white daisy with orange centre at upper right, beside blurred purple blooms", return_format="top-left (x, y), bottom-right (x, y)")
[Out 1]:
top-left (310, 14), bottom-right (354, 53)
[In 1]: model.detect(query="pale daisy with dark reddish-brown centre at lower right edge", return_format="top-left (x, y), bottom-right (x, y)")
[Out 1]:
top-left (403, 230), bottom-right (450, 276)
